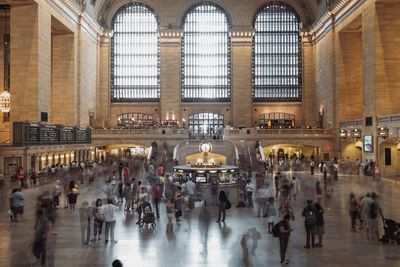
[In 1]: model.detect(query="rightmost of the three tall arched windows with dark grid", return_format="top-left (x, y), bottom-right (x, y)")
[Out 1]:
top-left (253, 2), bottom-right (302, 102)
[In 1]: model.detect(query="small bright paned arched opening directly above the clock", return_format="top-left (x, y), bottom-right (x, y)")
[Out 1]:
top-left (189, 113), bottom-right (224, 136)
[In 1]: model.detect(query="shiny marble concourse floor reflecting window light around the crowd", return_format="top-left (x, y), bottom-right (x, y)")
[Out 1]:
top-left (0, 173), bottom-right (400, 267)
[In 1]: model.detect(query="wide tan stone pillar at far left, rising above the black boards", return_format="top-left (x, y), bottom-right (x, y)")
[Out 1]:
top-left (10, 4), bottom-right (51, 122)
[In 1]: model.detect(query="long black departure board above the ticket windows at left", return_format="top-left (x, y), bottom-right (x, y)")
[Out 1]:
top-left (13, 122), bottom-right (92, 146)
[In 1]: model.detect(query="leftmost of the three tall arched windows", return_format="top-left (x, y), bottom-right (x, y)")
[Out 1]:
top-left (111, 3), bottom-right (160, 102)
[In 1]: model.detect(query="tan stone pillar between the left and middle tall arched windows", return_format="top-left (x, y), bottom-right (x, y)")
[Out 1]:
top-left (160, 29), bottom-right (182, 121)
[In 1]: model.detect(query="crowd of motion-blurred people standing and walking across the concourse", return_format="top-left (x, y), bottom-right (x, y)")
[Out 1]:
top-left (9, 149), bottom-right (392, 264)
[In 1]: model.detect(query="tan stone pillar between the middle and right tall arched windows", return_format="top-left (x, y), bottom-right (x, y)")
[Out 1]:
top-left (230, 28), bottom-right (254, 127)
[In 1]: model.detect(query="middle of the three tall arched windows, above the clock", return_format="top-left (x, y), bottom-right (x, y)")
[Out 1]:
top-left (182, 2), bottom-right (231, 102)
